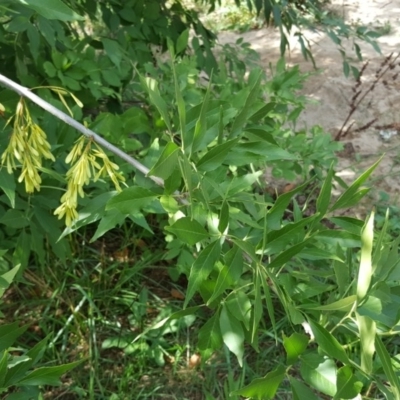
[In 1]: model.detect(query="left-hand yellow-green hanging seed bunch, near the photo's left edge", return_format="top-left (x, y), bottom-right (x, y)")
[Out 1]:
top-left (1, 99), bottom-right (55, 193)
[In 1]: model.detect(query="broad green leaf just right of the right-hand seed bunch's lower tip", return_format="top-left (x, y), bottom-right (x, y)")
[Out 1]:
top-left (106, 186), bottom-right (157, 214)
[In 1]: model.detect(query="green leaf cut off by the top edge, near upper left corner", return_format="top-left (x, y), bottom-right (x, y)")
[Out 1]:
top-left (17, 0), bottom-right (84, 22)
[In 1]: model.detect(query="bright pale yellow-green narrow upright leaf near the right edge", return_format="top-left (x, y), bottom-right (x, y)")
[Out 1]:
top-left (357, 212), bottom-right (374, 303)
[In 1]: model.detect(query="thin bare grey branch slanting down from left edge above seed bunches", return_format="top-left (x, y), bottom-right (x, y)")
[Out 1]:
top-left (0, 74), bottom-right (164, 186)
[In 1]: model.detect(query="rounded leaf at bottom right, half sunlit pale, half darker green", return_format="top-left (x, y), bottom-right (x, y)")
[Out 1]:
top-left (300, 354), bottom-right (336, 400)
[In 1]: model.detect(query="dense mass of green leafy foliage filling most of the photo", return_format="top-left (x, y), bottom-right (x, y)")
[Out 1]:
top-left (0, 0), bottom-right (400, 399)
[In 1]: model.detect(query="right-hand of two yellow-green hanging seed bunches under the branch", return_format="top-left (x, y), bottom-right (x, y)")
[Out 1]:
top-left (54, 136), bottom-right (125, 226)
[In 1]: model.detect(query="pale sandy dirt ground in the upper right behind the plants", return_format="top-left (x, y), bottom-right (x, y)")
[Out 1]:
top-left (219, 0), bottom-right (400, 200)
